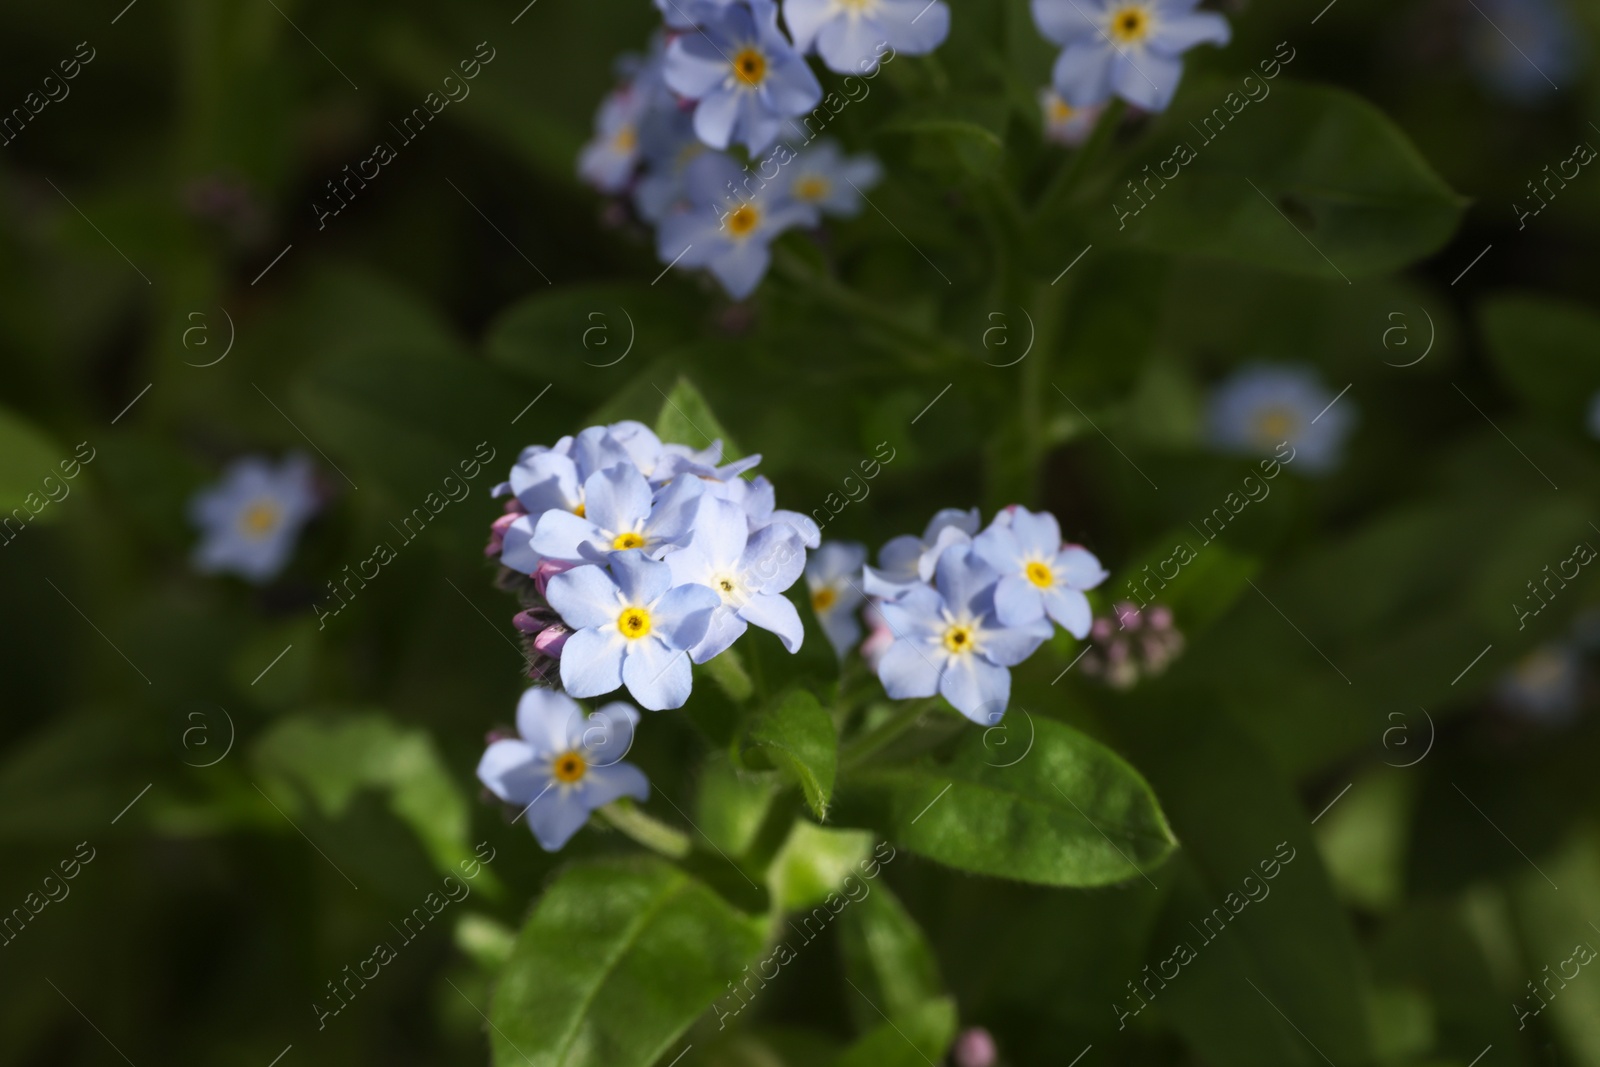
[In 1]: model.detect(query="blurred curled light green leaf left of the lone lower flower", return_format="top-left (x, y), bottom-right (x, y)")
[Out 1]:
top-left (253, 712), bottom-right (493, 880)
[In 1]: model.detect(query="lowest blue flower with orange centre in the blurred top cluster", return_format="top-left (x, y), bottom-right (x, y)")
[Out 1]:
top-left (656, 155), bottom-right (811, 301)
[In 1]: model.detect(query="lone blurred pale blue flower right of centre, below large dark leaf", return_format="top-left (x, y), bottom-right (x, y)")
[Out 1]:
top-left (1210, 363), bottom-right (1355, 472)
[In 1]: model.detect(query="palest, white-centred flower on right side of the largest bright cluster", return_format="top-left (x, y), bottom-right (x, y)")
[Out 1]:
top-left (666, 499), bottom-right (805, 664)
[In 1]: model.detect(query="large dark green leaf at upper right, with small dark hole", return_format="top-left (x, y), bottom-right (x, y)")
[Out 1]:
top-left (1078, 78), bottom-right (1464, 282)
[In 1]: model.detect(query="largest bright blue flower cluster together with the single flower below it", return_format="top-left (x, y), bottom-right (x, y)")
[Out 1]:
top-left (478, 422), bottom-right (821, 851)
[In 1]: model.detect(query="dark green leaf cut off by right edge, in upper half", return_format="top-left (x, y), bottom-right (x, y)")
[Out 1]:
top-left (1480, 296), bottom-right (1600, 430)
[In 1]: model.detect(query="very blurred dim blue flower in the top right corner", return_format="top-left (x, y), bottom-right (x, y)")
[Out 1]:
top-left (1462, 0), bottom-right (1582, 104)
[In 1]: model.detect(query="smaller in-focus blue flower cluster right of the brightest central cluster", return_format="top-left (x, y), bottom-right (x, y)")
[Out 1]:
top-left (806, 506), bottom-right (1107, 726)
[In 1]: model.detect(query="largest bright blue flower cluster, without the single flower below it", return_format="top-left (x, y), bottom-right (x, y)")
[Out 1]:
top-left (486, 422), bottom-right (821, 710)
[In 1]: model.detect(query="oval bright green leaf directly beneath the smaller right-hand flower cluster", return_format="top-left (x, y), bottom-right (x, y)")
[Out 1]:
top-left (851, 709), bottom-right (1176, 886)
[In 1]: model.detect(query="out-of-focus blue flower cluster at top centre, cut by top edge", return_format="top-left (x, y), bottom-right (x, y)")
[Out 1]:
top-left (578, 0), bottom-right (950, 299)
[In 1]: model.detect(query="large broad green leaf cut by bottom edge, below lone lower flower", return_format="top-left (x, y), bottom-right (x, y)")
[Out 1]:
top-left (490, 857), bottom-right (762, 1067)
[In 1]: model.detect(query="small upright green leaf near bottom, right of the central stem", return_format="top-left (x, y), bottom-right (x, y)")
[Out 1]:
top-left (838, 880), bottom-right (944, 1029)
